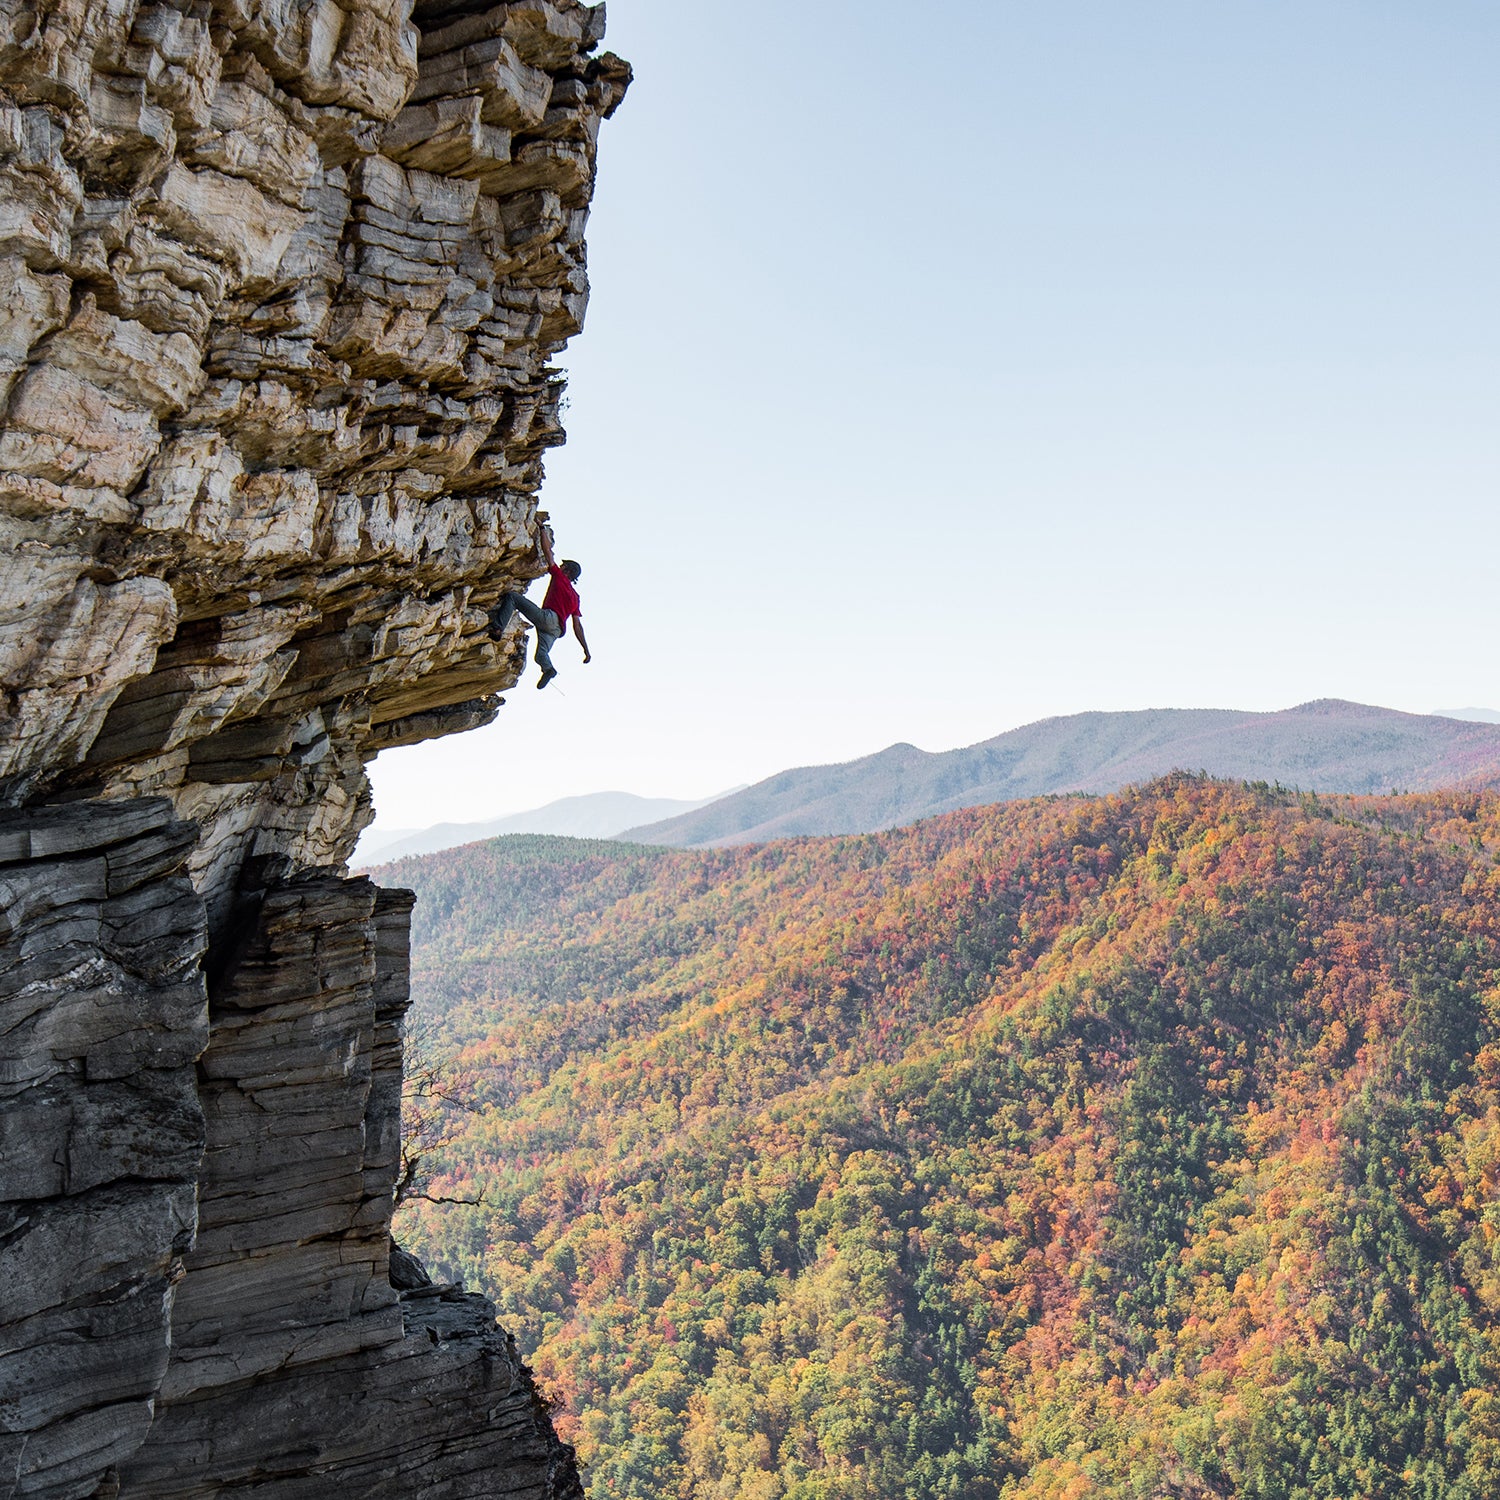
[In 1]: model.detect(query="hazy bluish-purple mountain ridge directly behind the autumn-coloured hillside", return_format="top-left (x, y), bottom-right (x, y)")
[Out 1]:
top-left (620, 698), bottom-right (1500, 848)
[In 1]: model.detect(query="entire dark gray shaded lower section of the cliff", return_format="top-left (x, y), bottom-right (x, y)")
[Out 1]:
top-left (0, 800), bottom-right (582, 1500)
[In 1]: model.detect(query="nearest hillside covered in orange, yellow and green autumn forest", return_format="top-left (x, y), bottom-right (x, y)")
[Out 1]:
top-left (383, 777), bottom-right (1500, 1500)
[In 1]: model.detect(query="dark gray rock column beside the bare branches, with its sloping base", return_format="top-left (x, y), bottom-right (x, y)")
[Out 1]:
top-left (109, 878), bottom-right (582, 1500)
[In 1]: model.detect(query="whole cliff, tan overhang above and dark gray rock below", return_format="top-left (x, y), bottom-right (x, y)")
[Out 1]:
top-left (0, 0), bottom-right (629, 1500)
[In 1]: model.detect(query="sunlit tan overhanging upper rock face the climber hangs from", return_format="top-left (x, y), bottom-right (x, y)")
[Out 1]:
top-left (0, 0), bottom-right (629, 870)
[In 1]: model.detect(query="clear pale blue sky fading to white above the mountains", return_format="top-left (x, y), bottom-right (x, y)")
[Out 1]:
top-left (371, 0), bottom-right (1500, 828)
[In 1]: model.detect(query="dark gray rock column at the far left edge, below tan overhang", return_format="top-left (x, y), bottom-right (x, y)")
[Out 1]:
top-left (0, 800), bottom-right (209, 1497)
